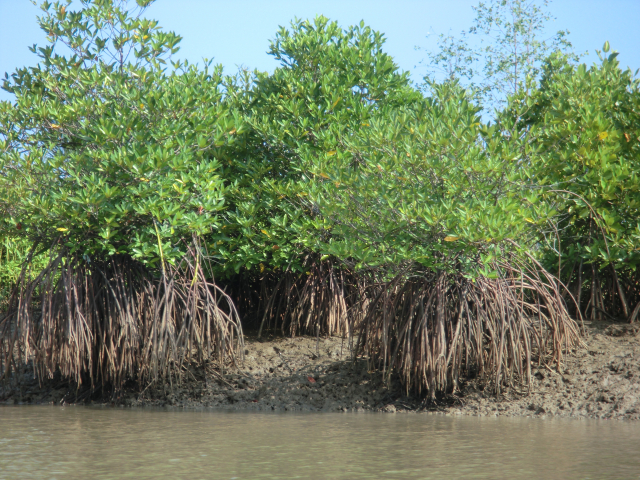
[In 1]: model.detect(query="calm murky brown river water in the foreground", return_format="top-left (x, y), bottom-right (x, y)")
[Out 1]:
top-left (0, 406), bottom-right (640, 479)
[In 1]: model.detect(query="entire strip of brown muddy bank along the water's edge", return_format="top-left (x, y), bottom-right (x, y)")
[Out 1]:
top-left (0, 322), bottom-right (640, 420)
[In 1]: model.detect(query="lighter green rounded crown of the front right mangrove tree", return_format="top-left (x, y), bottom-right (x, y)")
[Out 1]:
top-left (298, 83), bottom-right (541, 277)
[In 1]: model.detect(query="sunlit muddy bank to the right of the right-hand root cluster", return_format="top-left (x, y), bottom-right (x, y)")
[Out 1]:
top-left (446, 322), bottom-right (640, 420)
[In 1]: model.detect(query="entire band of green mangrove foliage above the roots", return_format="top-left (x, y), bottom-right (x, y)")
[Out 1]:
top-left (0, 1), bottom-right (638, 300)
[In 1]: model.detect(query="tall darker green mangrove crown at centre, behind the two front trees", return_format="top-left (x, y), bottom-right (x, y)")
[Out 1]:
top-left (219, 17), bottom-right (421, 272)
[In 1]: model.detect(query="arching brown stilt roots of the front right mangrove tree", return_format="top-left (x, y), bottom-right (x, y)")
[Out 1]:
top-left (358, 263), bottom-right (580, 398)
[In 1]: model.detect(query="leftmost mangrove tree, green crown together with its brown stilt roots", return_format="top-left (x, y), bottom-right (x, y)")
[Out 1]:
top-left (0, 0), bottom-right (243, 388)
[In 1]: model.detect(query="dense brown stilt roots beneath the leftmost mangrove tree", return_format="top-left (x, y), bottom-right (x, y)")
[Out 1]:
top-left (0, 244), bottom-right (242, 388)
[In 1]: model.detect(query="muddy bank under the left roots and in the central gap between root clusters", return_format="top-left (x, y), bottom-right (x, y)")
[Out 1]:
top-left (0, 336), bottom-right (396, 411)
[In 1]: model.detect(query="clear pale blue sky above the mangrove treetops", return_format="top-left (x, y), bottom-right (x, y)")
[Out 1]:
top-left (0, 0), bottom-right (640, 100)
